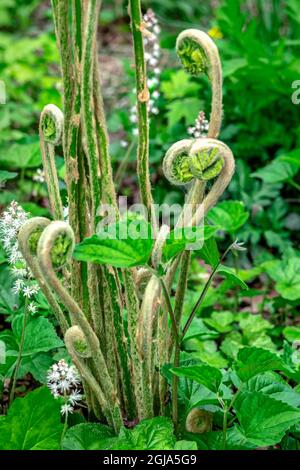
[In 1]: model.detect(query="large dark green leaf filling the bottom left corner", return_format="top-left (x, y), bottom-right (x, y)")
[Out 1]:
top-left (0, 387), bottom-right (63, 450)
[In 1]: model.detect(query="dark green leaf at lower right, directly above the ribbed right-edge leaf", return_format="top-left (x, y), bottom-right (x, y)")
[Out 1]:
top-left (234, 347), bottom-right (284, 382)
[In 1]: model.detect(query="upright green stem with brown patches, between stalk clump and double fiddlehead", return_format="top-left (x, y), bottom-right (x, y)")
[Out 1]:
top-left (129, 0), bottom-right (154, 226)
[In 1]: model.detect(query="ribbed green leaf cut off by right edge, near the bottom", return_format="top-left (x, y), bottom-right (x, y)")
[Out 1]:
top-left (243, 371), bottom-right (300, 408)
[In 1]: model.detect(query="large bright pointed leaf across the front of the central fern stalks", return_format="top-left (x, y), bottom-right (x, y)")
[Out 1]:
top-left (73, 219), bottom-right (154, 268)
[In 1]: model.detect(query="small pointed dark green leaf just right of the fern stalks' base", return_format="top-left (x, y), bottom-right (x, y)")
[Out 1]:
top-left (171, 364), bottom-right (223, 393)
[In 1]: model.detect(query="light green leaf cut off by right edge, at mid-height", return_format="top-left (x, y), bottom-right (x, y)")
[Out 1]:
top-left (264, 256), bottom-right (300, 300)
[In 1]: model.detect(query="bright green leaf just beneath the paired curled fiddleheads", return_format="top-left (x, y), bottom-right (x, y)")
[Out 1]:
top-left (163, 225), bottom-right (217, 262)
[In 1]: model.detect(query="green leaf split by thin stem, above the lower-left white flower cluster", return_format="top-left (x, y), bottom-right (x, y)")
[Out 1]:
top-left (12, 315), bottom-right (64, 357)
